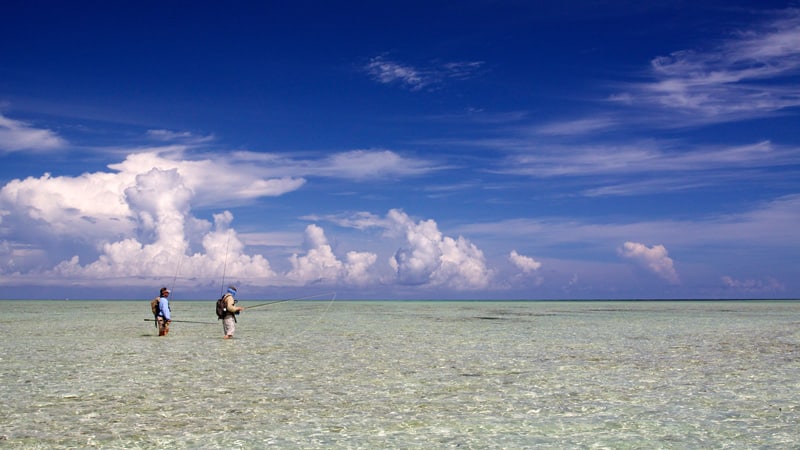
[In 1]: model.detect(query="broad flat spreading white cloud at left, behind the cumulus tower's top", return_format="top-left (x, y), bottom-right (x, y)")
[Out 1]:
top-left (0, 147), bottom-right (305, 244)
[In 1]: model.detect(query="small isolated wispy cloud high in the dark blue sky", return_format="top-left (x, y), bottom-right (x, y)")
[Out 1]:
top-left (364, 56), bottom-right (483, 91)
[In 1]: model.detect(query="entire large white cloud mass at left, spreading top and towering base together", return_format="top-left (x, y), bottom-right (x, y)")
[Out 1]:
top-left (0, 147), bottom-right (296, 284)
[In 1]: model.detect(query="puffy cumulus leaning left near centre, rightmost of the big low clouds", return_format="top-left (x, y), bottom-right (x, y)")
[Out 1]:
top-left (387, 209), bottom-right (492, 289)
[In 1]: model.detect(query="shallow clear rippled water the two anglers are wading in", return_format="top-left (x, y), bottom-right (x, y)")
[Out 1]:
top-left (0, 300), bottom-right (800, 449)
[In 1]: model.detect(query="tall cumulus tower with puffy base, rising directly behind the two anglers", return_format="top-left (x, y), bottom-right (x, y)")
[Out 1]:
top-left (48, 185), bottom-right (276, 285)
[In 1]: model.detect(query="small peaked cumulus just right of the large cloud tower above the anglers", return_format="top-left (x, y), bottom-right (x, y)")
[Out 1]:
top-left (286, 224), bottom-right (377, 284)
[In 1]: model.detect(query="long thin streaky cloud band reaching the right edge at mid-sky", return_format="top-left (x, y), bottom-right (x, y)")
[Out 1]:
top-left (495, 141), bottom-right (800, 197)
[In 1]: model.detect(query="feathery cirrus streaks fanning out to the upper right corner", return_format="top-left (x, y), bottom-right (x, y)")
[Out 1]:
top-left (611, 9), bottom-right (800, 122)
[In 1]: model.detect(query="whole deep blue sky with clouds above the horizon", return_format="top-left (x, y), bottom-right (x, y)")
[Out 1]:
top-left (0, 0), bottom-right (800, 300)
